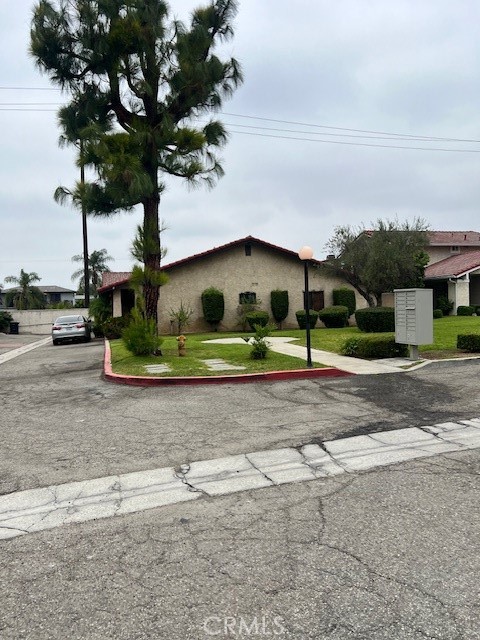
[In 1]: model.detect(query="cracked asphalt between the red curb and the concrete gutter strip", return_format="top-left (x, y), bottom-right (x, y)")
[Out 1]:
top-left (0, 341), bottom-right (480, 494)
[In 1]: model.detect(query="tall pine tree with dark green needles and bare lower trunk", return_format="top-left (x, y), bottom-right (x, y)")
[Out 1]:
top-left (30, 0), bottom-right (242, 321)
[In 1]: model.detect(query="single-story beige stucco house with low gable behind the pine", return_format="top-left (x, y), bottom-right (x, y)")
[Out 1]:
top-left (98, 236), bottom-right (365, 333)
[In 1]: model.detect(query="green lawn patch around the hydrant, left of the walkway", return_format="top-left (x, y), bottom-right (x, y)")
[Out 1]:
top-left (110, 332), bottom-right (321, 377)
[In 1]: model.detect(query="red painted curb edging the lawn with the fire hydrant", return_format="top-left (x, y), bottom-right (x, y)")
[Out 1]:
top-left (103, 340), bottom-right (355, 387)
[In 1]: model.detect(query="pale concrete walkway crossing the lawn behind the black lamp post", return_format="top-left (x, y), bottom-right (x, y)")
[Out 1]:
top-left (206, 336), bottom-right (416, 375)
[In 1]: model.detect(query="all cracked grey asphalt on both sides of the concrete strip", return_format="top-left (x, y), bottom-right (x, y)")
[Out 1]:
top-left (0, 342), bottom-right (480, 640)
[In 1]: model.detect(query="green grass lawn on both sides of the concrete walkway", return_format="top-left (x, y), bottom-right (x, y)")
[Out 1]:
top-left (111, 316), bottom-right (480, 376)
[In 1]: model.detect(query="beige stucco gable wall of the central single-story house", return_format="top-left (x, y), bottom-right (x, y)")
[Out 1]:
top-left (159, 243), bottom-right (365, 333)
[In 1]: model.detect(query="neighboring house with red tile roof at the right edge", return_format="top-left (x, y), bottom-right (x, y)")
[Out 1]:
top-left (425, 231), bottom-right (480, 313)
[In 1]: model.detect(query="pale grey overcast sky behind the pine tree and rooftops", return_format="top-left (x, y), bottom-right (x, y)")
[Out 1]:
top-left (0, 0), bottom-right (480, 288)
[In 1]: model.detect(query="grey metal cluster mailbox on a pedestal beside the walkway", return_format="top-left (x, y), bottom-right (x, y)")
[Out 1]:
top-left (394, 289), bottom-right (433, 360)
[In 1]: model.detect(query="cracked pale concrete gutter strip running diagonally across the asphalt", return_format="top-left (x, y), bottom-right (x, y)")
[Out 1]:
top-left (0, 418), bottom-right (480, 540)
